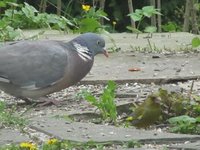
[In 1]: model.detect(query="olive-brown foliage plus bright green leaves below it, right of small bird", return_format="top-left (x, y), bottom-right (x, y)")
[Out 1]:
top-left (158, 89), bottom-right (200, 134)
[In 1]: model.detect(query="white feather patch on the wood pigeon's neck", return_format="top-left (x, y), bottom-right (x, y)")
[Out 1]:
top-left (73, 42), bottom-right (92, 61)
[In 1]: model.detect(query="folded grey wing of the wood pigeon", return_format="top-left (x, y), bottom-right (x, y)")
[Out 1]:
top-left (0, 41), bottom-right (68, 89)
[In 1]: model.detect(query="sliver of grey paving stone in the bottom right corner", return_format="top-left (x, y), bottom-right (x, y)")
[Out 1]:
top-left (169, 141), bottom-right (200, 150)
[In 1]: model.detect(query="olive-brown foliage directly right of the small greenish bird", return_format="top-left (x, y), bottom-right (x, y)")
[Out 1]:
top-left (157, 88), bottom-right (200, 120)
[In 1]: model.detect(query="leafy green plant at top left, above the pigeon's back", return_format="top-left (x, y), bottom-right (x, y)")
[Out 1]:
top-left (2, 3), bottom-right (74, 30)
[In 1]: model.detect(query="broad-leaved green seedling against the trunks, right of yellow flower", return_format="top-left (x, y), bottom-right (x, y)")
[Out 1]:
top-left (127, 6), bottom-right (161, 33)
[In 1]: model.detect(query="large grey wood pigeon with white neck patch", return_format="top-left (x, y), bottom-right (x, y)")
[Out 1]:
top-left (0, 33), bottom-right (108, 103)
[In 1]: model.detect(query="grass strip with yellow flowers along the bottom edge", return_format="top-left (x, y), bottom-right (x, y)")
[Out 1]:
top-left (0, 138), bottom-right (141, 150)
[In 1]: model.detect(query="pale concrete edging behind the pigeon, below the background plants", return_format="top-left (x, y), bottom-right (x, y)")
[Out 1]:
top-left (19, 29), bottom-right (198, 51)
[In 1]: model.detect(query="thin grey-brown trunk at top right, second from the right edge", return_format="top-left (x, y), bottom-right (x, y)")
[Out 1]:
top-left (183, 0), bottom-right (191, 32)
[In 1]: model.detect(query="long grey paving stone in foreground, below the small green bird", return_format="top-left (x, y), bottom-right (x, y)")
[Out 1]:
top-left (31, 117), bottom-right (200, 144)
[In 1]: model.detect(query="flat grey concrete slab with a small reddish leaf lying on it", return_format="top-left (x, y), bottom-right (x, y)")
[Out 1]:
top-left (82, 53), bottom-right (200, 84)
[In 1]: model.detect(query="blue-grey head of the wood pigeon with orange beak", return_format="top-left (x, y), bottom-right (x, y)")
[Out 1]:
top-left (72, 33), bottom-right (108, 57)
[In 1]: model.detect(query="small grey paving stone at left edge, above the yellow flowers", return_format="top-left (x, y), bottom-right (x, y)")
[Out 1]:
top-left (0, 128), bottom-right (30, 146)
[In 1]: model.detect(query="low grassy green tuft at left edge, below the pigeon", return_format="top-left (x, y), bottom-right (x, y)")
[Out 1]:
top-left (0, 101), bottom-right (26, 128)
